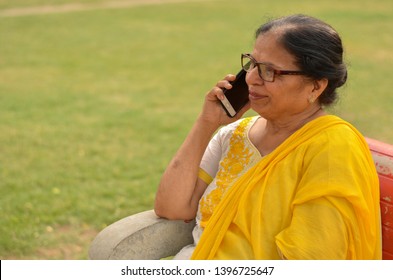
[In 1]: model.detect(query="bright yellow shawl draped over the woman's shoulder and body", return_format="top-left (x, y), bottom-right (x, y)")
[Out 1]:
top-left (192, 115), bottom-right (381, 259)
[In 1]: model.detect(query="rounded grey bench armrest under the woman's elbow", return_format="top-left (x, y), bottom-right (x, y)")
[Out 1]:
top-left (89, 210), bottom-right (195, 260)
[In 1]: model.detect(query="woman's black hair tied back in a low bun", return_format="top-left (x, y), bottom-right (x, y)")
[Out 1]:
top-left (256, 14), bottom-right (347, 105)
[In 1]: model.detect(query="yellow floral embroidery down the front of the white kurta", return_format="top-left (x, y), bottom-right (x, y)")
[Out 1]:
top-left (199, 118), bottom-right (252, 228)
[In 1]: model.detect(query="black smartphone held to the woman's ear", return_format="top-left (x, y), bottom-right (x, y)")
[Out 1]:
top-left (220, 69), bottom-right (249, 118)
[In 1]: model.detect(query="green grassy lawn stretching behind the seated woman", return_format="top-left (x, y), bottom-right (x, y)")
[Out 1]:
top-left (0, 0), bottom-right (393, 259)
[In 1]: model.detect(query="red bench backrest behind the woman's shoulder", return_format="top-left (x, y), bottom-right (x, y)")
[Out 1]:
top-left (366, 138), bottom-right (393, 260)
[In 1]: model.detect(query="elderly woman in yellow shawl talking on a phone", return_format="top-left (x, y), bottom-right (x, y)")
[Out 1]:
top-left (155, 15), bottom-right (381, 259)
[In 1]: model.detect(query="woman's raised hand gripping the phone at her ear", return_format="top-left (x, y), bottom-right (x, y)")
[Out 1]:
top-left (199, 74), bottom-right (250, 128)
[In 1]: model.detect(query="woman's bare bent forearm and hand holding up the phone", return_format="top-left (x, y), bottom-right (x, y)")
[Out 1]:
top-left (154, 75), bottom-right (249, 220)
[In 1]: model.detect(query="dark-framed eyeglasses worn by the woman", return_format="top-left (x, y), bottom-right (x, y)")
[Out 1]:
top-left (241, 53), bottom-right (304, 82)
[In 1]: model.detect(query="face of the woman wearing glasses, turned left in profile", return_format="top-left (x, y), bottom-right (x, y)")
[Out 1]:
top-left (246, 31), bottom-right (317, 122)
